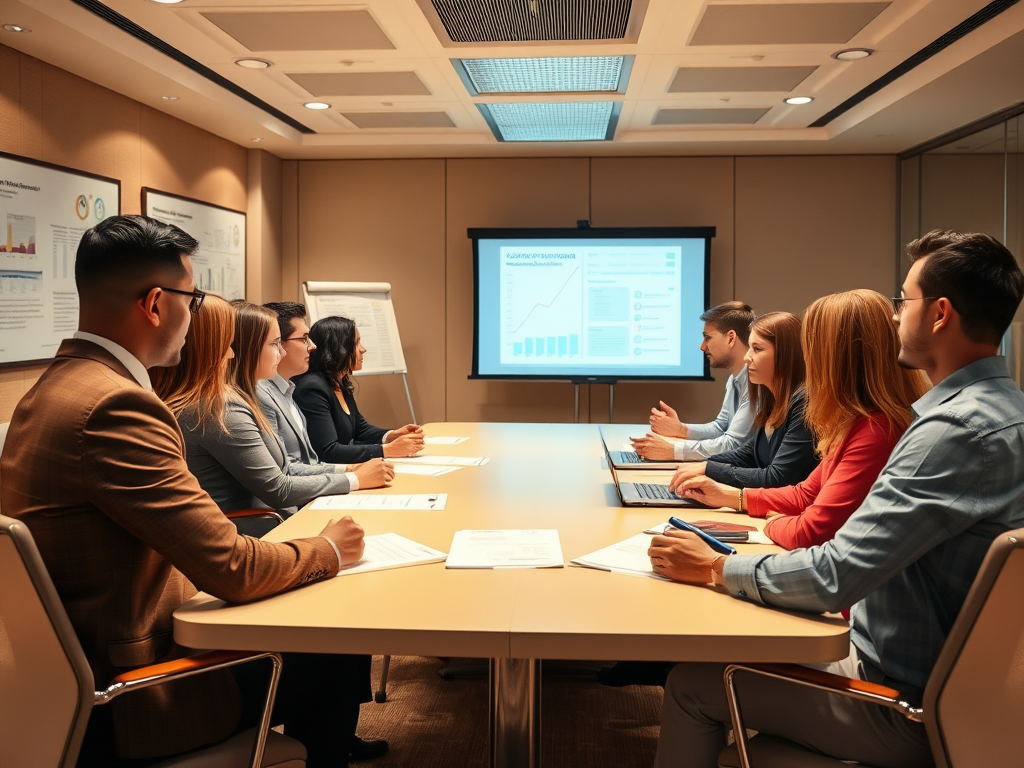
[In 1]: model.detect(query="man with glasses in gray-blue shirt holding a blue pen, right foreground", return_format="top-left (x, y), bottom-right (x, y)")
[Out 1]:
top-left (650, 231), bottom-right (1024, 768)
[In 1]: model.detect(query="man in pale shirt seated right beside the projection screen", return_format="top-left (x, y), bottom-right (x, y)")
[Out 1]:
top-left (633, 301), bottom-right (754, 461)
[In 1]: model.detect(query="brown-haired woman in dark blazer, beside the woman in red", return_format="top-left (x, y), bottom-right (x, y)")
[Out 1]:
top-left (670, 312), bottom-right (818, 490)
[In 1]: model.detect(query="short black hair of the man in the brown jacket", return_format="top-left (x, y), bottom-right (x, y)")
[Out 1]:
top-left (75, 216), bottom-right (199, 298)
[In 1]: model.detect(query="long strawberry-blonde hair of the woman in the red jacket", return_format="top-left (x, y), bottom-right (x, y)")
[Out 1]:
top-left (802, 289), bottom-right (928, 456)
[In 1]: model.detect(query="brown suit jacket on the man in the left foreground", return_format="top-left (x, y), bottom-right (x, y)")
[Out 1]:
top-left (0, 340), bottom-right (338, 758)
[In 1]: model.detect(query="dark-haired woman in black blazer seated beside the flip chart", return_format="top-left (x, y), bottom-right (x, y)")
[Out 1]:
top-left (293, 317), bottom-right (423, 464)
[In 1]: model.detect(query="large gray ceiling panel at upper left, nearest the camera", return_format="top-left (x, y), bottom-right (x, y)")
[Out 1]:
top-left (202, 10), bottom-right (394, 51)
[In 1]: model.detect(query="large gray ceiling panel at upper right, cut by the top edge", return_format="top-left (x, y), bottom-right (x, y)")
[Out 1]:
top-left (690, 3), bottom-right (889, 45)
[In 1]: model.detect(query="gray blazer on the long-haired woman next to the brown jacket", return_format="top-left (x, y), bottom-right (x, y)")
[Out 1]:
top-left (178, 400), bottom-right (349, 515)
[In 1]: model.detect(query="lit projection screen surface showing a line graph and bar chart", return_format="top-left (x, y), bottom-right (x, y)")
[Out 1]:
top-left (474, 230), bottom-right (709, 380)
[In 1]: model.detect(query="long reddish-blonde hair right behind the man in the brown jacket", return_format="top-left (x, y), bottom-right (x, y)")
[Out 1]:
top-left (152, 294), bottom-right (234, 431)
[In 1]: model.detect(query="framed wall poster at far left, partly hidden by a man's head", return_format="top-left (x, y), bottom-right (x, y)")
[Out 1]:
top-left (0, 153), bottom-right (121, 365)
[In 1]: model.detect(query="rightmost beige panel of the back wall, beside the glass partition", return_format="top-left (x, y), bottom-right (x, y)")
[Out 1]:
top-left (735, 156), bottom-right (897, 314)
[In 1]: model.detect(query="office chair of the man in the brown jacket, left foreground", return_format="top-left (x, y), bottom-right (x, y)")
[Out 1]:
top-left (0, 516), bottom-right (306, 768)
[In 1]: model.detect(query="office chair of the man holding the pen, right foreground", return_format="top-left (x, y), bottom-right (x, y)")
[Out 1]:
top-left (718, 528), bottom-right (1024, 768)
